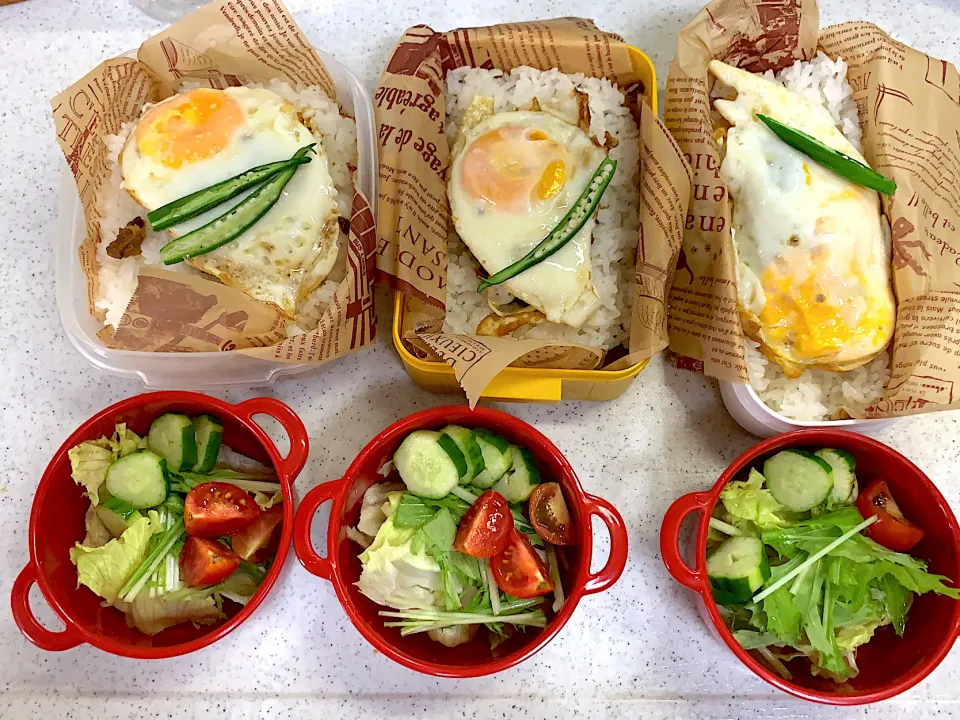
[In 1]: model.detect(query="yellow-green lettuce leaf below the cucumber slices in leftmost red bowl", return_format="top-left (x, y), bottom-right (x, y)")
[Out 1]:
top-left (70, 511), bottom-right (163, 604)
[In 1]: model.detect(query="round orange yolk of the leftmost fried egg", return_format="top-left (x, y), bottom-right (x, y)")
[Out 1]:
top-left (136, 88), bottom-right (244, 168)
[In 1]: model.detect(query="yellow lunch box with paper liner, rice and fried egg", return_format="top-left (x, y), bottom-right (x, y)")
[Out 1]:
top-left (374, 18), bottom-right (686, 403)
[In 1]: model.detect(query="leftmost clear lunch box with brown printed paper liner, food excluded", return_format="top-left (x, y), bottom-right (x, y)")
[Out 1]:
top-left (52, 2), bottom-right (378, 388)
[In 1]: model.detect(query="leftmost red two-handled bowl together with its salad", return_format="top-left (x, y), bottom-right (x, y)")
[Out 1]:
top-left (11, 391), bottom-right (308, 659)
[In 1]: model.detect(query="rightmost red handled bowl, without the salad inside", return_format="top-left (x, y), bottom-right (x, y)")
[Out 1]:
top-left (660, 428), bottom-right (960, 705)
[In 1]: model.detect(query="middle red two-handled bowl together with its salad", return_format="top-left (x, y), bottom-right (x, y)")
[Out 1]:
top-left (294, 406), bottom-right (627, 678)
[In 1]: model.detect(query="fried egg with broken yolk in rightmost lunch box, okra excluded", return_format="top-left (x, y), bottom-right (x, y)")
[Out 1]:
top-left (710, 61), bottom-right (896, 377)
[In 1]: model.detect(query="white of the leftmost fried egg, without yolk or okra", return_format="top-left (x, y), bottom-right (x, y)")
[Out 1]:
top-left (120, 87), bottom-right (338, 319)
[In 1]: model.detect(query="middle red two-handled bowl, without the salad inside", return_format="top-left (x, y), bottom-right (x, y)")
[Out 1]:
top-left (293, 405), bottom-right (627, 678)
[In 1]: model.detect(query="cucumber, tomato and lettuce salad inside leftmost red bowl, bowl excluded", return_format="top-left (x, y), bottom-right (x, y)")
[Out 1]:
top-left (68, 413), bottom-right (283, 635)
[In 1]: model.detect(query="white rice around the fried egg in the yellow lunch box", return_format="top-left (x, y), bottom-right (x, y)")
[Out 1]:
top-left (443, 67), bottom-right (640, 349)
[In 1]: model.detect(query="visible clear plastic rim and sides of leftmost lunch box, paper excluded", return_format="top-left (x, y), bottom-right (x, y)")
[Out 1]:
top-left (56, 51), bottom-right (377, 388)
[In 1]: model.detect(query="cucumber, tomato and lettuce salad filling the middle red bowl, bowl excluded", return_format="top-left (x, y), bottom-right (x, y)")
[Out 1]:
top-left (347, 425), bottom-right (577, 648)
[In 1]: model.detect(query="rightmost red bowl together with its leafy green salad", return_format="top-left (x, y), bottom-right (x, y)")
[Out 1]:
top-left (660, 428), bottom-right (960, 705)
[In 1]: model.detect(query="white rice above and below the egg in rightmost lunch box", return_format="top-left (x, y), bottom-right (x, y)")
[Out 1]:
top-left (746, 53), bottom-right (890, 421)
